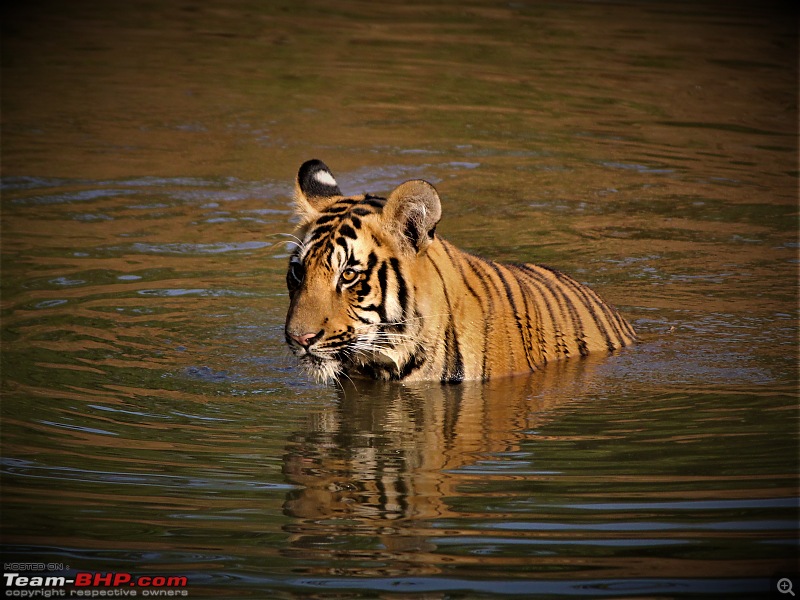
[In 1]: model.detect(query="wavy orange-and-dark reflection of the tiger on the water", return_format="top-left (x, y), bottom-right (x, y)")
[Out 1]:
top-left (284, 358), bottom-right (598, 576)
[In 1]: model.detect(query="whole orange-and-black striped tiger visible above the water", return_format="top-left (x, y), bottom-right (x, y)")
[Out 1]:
top-left (285, 160), bottom-right (636, 383)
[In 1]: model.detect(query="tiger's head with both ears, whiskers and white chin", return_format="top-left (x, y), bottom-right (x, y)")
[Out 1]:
top-left (285, 160), bottom-right (441, 381)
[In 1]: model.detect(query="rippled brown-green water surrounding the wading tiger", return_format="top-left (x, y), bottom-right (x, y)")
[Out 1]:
top-left (0, 0), bottom-right (800, 598)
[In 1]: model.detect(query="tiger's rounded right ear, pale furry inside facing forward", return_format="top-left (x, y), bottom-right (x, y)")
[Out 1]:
top-left (382, 179), bottom-right (442, 254)
